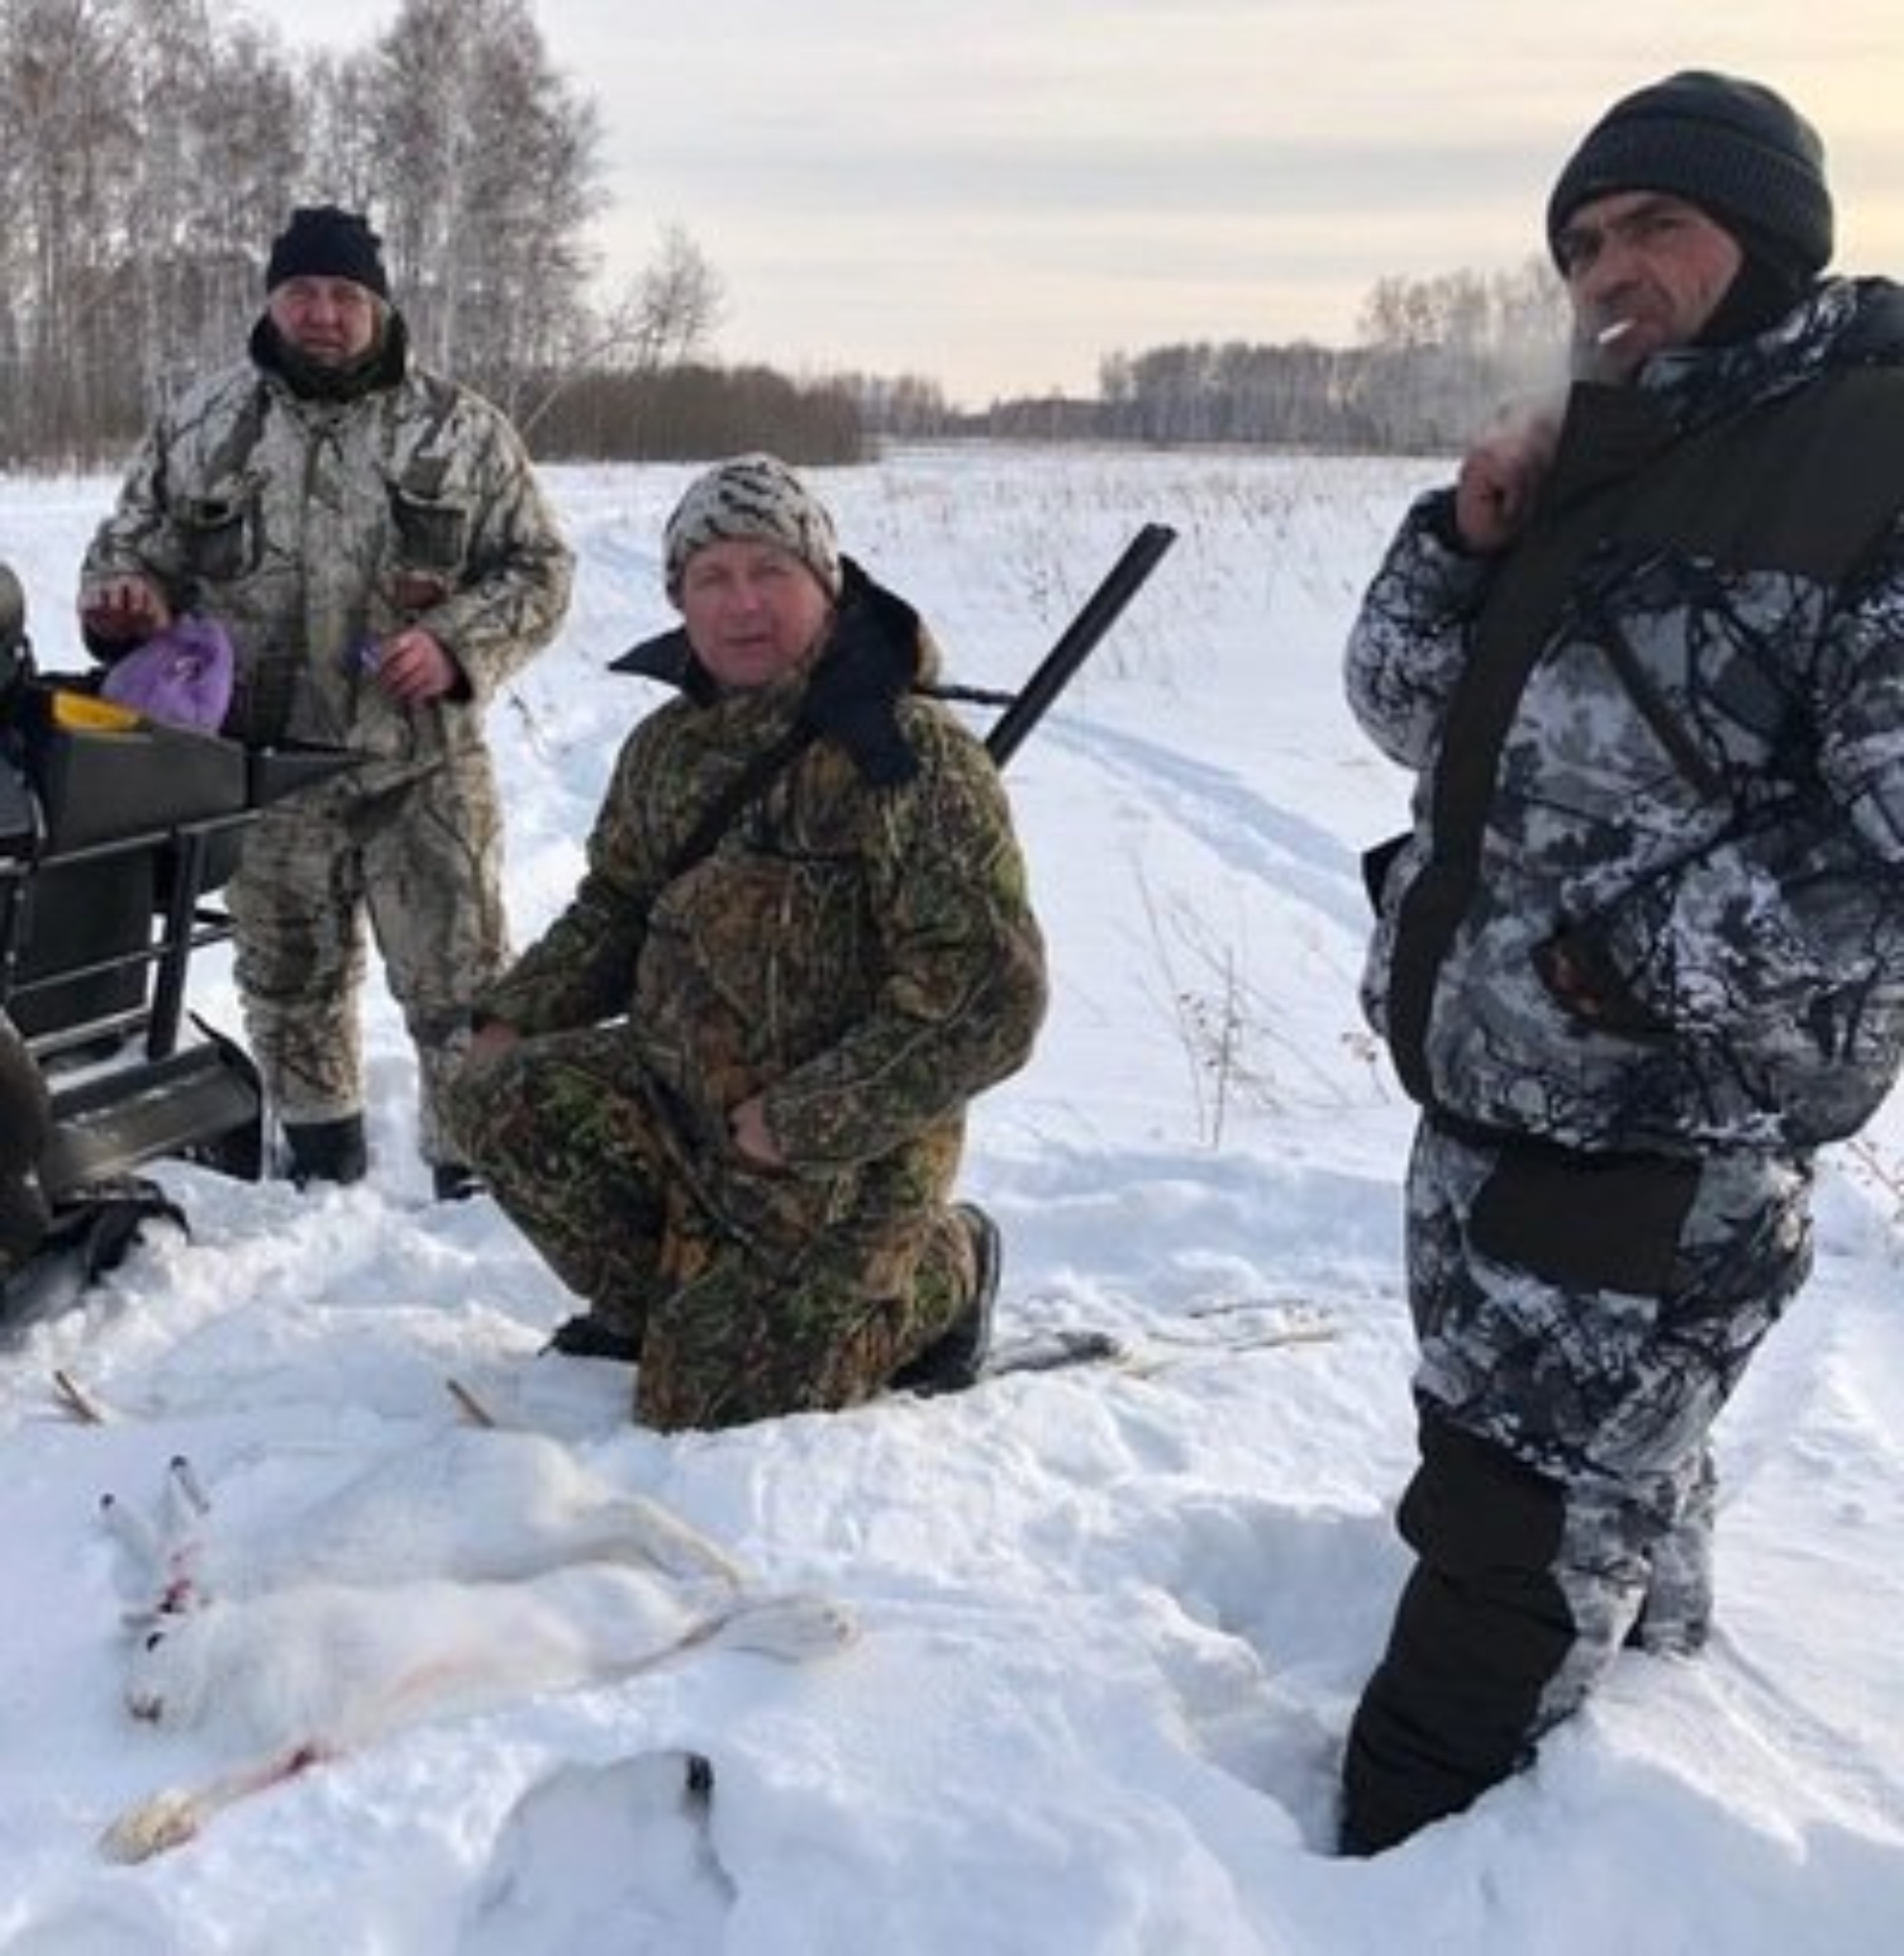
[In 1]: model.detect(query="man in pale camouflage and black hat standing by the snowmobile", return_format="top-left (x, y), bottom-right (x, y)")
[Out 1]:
top-left (80, 205), bottom-right (573, 1197)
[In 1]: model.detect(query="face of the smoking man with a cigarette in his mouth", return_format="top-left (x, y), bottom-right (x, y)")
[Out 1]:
top-left (1554, 189), bottom-right (1743, 380)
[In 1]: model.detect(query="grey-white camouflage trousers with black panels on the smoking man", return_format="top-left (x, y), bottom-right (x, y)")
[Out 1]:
top-left (1343, 1123), bottom-right (1812, 1852)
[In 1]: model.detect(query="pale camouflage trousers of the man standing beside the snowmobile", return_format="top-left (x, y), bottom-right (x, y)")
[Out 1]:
top-left (227, 753), bottom-right (509, 1161)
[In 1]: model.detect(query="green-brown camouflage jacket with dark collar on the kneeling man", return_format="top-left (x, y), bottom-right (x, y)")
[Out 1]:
top-left (479, 567), bottom-right (1046, 1187)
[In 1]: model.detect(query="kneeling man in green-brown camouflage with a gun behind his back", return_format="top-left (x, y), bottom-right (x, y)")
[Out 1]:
top-left (455, 455), bottom-right (1046, 1430)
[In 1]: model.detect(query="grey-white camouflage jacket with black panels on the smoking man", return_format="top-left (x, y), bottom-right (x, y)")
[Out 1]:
top-left (1347, 280), bottom-right (1904, 1153)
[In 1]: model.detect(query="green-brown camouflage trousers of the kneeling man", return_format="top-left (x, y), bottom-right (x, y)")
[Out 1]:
top-left (451, 1027), bottom-right (978, 1432)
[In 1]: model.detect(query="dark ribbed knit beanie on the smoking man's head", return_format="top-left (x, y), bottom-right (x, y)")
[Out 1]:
top-left (1546, 68), bottom-right (1832, 288)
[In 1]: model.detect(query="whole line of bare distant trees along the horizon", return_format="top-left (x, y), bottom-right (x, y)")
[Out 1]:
top-left (0, 0), bottom-right (1566, 469)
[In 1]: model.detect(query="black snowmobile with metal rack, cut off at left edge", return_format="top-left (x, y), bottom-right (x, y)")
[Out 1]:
top-left (0, 565), bottom-right (350, 1326)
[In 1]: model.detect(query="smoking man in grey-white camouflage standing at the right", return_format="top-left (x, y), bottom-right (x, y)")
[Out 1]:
top-left (1343, 72), bottom-right (1904, 1854)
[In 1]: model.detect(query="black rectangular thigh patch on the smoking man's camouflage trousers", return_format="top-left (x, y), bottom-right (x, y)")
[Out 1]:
top-left (1468, 1147), bottom-right (1699, 1296)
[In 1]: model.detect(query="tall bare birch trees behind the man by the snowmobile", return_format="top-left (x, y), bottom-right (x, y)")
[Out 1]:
top-left (0, 0), bottom-right (719, 465)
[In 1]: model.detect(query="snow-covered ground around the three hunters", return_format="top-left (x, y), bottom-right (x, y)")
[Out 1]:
top-left (0, 450), bottom-right (1904, 1956)
